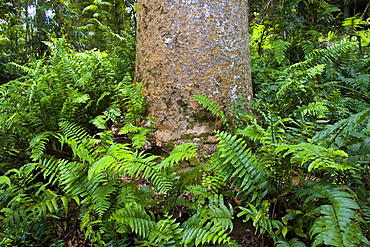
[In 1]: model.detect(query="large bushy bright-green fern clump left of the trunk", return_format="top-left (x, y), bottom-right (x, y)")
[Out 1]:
top-left (0, 40), bottom-right (147, 164)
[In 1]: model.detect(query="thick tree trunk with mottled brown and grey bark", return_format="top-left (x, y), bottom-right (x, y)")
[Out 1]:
top-left (136, 0), bottom-right (252, 143)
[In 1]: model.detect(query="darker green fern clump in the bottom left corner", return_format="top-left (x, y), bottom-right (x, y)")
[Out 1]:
top-left (0, 163), bottom-right (70, 245)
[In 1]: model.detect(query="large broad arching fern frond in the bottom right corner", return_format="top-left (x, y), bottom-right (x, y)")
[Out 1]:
top-left (299, 184), bottom-right (370, 247)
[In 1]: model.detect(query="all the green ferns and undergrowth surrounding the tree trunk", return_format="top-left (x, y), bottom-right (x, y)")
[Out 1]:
top-left (0, 0), bottom-right (370, 247)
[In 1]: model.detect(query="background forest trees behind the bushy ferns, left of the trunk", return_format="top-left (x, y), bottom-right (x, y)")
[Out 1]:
top-left (0, 0), bottom-right (136, 81)
